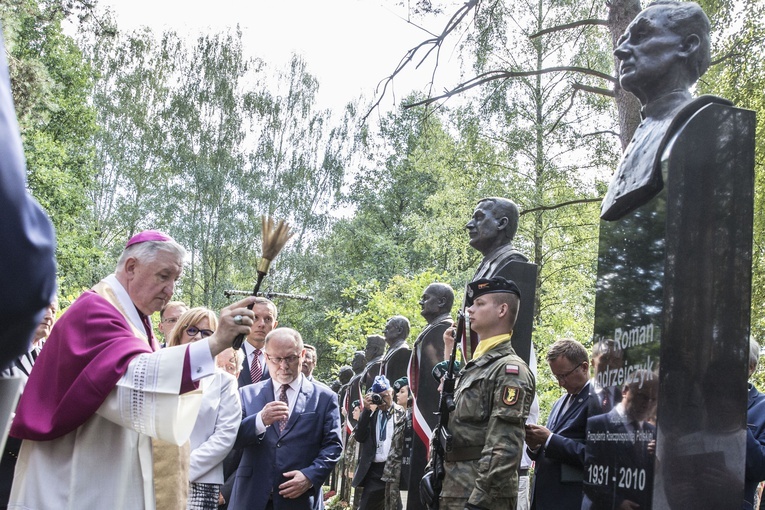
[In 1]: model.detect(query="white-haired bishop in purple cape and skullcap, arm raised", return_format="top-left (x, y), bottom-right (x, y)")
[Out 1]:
top-left (9, 230), bottom-right (253, 510)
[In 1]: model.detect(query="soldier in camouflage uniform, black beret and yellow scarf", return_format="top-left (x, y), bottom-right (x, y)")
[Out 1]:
top-left (440, 277), bottom-right (535, 510)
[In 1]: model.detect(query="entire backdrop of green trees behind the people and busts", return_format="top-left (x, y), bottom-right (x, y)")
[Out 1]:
top-left (14, 0), bottom-right (765, 422)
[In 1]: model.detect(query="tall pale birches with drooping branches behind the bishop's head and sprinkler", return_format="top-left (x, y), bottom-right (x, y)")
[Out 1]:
top-left (84, 24), bottom-right (352, 314)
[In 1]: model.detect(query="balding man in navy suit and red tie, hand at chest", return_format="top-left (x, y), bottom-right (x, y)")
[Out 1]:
top-left (229, 328), bottom-right (343, 510)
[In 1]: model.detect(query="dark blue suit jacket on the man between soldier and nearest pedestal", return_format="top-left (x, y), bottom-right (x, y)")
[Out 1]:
top-left (527, 382), bottom-right (591, 510)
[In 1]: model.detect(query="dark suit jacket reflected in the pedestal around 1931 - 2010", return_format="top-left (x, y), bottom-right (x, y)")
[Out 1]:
top-left (582, 409), bottom-right (656, 510)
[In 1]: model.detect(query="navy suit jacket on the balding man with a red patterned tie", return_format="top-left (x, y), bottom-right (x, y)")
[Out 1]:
top-left (229, 378), bottom-right (343, 510)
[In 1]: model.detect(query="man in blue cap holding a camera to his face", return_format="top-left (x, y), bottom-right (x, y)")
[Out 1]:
top-left (352, 375), bottom-right (405, 510)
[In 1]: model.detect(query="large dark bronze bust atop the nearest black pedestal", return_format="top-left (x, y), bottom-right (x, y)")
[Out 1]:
top-left (600, 0), bottom-right (730, 221)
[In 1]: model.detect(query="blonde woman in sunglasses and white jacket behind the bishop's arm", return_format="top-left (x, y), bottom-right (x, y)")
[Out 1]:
top-left (168, 307), bottom-right (242, 510)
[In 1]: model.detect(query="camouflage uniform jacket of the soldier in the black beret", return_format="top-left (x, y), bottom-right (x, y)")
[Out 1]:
top-left (441, 341), bottom-right (535, 509)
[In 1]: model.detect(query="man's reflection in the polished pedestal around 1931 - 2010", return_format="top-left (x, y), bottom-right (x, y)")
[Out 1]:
top-left (582, 369), bottom-right (659, 510)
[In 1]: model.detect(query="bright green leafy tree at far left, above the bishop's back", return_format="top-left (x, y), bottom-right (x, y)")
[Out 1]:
top-left (0, 0), bottom-right (102, 295)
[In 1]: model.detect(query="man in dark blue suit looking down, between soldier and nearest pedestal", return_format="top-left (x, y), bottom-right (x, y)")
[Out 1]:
top-left (526, 339), bottom-right (591, 510)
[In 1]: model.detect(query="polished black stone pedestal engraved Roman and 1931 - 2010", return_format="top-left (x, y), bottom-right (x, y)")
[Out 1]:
top-left (585, 104), bottom-right (755, 510)
